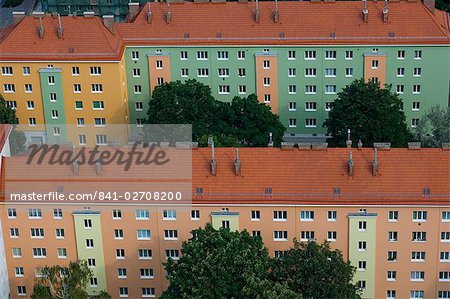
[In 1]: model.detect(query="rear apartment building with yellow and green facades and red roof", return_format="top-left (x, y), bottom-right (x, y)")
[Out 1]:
top-left (0, 1), bottom-right (450, 144)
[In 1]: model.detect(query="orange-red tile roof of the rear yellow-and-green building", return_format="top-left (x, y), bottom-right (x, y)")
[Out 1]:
top-left (0, 1), bottom-right (450, 60)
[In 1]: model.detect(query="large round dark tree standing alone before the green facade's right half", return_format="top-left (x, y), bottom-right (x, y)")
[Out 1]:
top-left (323, 79), bottom-right (412, 147)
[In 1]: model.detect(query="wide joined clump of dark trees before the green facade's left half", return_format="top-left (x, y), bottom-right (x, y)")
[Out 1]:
top-left (147, 80), bottom-right (286, 146)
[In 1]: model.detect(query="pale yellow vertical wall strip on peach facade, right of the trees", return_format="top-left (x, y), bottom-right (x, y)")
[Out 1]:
top-left (348, 213), bottom-right (377, 298)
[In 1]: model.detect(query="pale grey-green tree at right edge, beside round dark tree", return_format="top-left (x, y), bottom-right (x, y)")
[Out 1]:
top-left (414, 105), bottom-right (450, 147)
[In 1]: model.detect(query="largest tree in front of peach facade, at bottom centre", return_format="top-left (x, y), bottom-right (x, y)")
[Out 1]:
top-left (161, 224), bottom-right (299, 298)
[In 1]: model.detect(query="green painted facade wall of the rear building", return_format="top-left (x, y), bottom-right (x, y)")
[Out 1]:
top-left (125, 45), bottom-right (450, 134)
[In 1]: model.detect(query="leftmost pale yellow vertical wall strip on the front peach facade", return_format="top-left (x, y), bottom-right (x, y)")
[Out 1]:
top-left (73, 211), bottom-right (106, 295)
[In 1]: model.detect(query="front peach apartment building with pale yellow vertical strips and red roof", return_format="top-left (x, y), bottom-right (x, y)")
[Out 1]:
top-left (0, 142), bottom-right (450, 299)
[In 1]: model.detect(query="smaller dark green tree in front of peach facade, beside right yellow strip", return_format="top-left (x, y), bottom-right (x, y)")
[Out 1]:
top-left (271, 240), bottom-right (359, 298)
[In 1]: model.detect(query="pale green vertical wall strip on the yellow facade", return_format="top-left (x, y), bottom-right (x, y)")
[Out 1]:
top-left (39, 68), bottom-right (67, 143)
